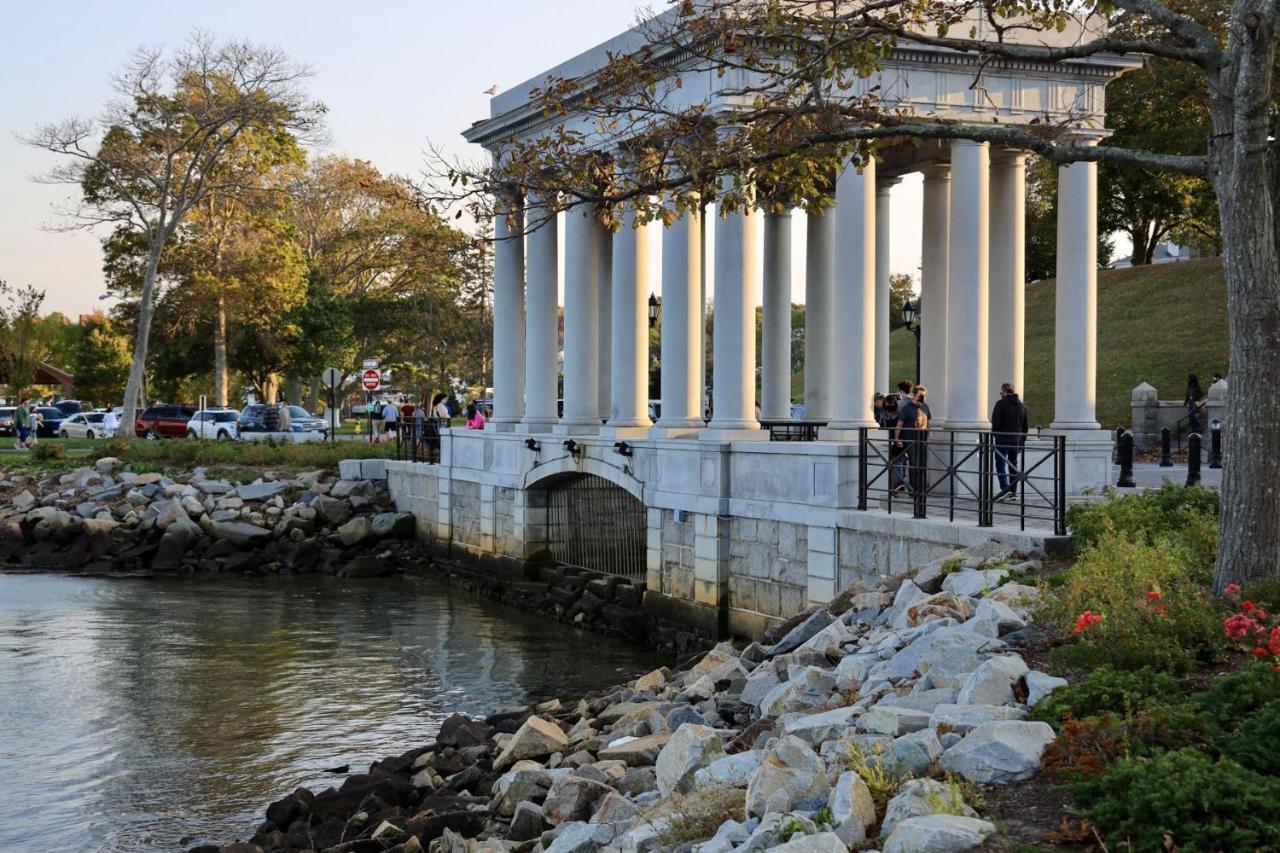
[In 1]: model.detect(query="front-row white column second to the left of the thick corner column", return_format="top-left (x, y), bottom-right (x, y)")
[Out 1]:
top-left (657, 204), bottom-right (703, 438)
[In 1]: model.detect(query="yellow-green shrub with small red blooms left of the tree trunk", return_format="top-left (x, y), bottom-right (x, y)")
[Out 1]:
top-left (1042, 532), bottom-right (1225, 672)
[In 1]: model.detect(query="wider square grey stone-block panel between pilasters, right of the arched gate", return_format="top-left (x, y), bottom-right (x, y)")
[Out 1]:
top-left (728, 519), bottom-right (809, 619)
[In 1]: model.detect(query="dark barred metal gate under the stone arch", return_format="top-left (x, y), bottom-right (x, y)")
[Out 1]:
top-left (547, 474), bottom-right (648, 580)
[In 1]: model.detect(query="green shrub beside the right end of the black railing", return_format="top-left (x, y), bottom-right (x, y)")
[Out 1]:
top-left (1068, 483), bottom-right (1219, 573)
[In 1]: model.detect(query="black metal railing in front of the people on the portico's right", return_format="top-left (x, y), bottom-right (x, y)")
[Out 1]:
top-left (858, 428), bottom-right (1066, 535)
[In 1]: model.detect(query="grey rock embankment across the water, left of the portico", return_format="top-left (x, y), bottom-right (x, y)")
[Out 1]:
top-left (0, 459), bottom-right (417, 578)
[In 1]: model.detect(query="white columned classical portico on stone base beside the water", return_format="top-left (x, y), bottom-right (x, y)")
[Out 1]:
top-left (389, 14), bottom-right (1132, 634)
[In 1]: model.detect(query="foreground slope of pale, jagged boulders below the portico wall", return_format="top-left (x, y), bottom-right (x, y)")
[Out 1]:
top-left (212, 540), bottom-right (1065, 853)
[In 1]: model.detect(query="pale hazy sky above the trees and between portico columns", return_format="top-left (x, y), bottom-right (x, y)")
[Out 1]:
top-left (0, 0), bottom-right (920, 318)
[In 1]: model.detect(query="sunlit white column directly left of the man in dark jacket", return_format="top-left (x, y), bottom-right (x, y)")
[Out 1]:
top-left (942, 140), bottom-right (991, 429)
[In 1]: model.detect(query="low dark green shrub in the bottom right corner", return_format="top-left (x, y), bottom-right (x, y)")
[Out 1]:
top-left (1073, 748), bottom-right (1280, 853)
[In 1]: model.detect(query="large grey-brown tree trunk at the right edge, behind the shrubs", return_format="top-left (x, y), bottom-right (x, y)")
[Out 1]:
top-left (1210, 0), bottom-right (1280, 592)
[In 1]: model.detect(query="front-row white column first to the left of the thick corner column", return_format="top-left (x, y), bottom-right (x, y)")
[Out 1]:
top-left (701, 199), bottom-right (769, 441)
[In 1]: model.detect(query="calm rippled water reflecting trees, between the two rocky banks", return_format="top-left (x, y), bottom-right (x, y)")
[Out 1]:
top-left (0, 575), bottom-right (666, 850)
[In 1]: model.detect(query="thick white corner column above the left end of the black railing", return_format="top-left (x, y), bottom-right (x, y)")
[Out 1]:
top-left (829, 160), bottom-right (876, 438)
